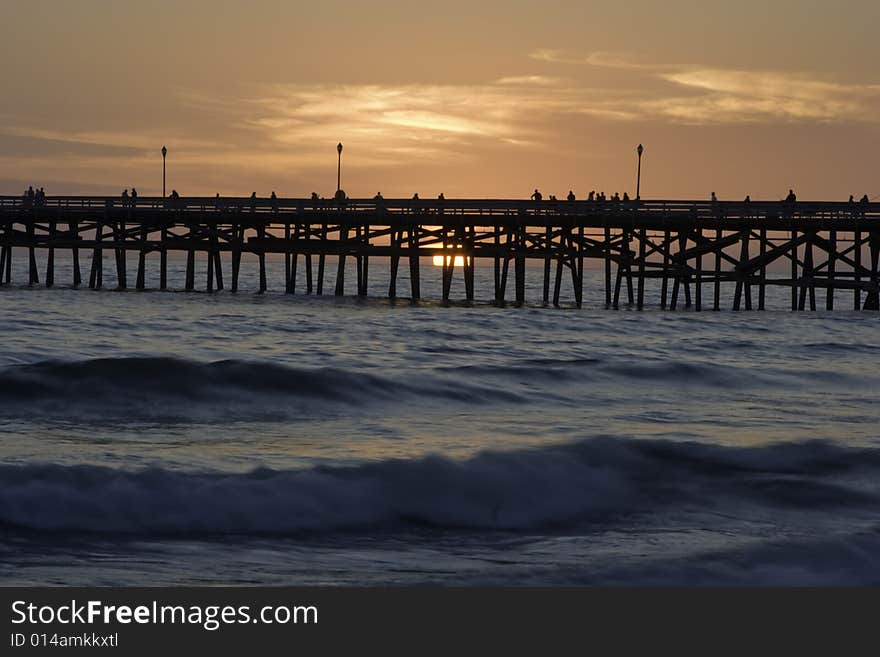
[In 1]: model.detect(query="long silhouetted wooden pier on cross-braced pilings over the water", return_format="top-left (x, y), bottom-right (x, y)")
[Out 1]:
top-left (0, 196), bottom-right (880, 311)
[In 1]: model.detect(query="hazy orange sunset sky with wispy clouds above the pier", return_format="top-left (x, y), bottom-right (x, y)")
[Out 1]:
top-left (0, 0), bottom-right (880, 200)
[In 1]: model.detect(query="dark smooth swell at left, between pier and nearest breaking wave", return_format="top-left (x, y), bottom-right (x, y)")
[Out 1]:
top-left (0, 357), bottom-right (520, 418)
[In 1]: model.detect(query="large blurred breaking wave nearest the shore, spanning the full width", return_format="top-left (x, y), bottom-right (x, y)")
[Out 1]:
top-left (0, 438), bottom-right (880, 535)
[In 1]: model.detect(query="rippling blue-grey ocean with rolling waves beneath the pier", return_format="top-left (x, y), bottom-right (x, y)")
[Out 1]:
top-left (0, 252), bottom-right (880, 586)
